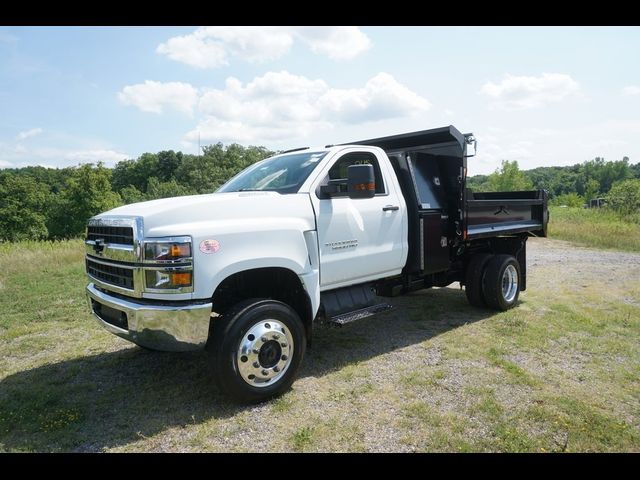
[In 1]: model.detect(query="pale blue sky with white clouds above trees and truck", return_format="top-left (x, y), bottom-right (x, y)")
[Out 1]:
top-left (0, 26), bottom-right (640, 175)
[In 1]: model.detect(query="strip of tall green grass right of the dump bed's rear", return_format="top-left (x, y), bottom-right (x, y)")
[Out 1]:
top-left (549, 207), bottom-right (640, 252)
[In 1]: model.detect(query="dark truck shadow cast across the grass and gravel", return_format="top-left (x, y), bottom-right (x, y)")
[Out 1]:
top-left (0, 288), bottom-right (493, 451)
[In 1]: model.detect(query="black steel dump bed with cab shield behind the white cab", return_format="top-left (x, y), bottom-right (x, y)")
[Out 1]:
top-left (349, 125), bottom-right (548, 273)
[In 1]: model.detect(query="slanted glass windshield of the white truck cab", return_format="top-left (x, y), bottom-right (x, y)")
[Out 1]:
top-left (218, 152), bottom-right (327, 193)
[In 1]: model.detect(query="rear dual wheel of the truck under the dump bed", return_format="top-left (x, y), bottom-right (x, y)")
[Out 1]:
top-left (482, 255), bottom-right (521, 311)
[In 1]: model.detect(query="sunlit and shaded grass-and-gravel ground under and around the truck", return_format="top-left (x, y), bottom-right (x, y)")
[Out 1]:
top-left (0, 239), bottom-right (640, 452)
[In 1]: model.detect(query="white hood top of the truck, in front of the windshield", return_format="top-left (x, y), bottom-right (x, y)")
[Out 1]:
top-left (95, 192), bottom-right (315, 236)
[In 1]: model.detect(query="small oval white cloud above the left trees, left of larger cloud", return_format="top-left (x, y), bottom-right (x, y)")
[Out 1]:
top-left (118, 80), bottom-right (198, 114)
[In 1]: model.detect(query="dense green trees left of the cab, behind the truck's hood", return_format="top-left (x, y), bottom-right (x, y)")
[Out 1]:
top-left (0, 143), bottom-right (274, 241)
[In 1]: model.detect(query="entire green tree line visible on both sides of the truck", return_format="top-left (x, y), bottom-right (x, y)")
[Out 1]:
top-left (0, 143), bottom-right (640, 241)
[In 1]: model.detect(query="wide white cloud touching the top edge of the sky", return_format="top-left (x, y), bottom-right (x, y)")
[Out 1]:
top-left (156, 26), bottom-right (371, 68)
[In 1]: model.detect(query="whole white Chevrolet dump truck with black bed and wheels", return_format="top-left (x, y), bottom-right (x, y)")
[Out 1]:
top-left (86, 126), bottom-right (548, 402)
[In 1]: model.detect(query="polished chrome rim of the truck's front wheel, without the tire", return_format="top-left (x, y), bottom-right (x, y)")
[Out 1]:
top-left (236, 319), bottom-right (293, 387)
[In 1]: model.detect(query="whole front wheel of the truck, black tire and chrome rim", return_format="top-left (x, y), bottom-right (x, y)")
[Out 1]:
top-left (207, 299), bottom-right (306, 403)
